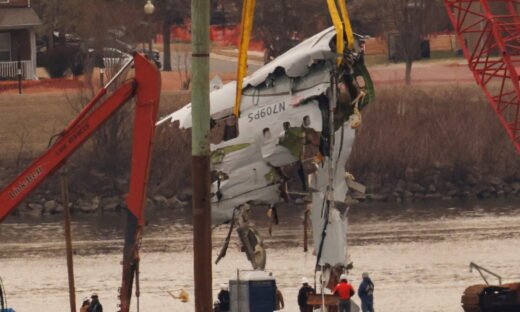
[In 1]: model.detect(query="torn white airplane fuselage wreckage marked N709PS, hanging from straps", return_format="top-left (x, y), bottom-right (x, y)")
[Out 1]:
top-left (158, 27), bottom-right (374, 282)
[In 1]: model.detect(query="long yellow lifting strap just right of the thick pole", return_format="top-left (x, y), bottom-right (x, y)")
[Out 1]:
top-left (233, 0), bottom-right (256, 118)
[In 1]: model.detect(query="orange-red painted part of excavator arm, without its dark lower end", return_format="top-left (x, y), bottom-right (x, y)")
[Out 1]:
top-left (0, 53), bottom-right (161, 225)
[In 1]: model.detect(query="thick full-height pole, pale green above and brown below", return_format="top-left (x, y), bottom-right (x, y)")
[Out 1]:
top-left (191, 0), bottom-right (213, 312)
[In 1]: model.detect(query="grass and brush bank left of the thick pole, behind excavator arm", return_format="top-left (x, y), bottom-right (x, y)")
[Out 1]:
top-left (0, 91), bottom-right (191, 215)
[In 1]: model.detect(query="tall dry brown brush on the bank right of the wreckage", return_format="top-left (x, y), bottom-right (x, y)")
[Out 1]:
top-left (348, 85), bottom-right (520, 181)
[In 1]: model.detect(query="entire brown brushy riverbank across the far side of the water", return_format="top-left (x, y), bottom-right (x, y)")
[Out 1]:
top-left (0, 85), bottom-right (520, 215)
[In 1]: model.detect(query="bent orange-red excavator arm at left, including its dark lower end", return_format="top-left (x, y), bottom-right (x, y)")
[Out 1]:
top-left (0, 53), bottom-right (161, 312)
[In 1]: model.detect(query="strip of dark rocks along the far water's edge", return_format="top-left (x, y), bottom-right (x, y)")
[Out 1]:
top-left (0, 166), bottom-right (520, 217)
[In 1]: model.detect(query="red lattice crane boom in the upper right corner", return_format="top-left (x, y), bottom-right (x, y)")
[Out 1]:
top-left (444, 0), bottom-right (520, 152)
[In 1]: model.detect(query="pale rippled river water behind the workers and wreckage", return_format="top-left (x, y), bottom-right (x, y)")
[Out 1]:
top-left (0, 200), bottom-right (520, 312)
